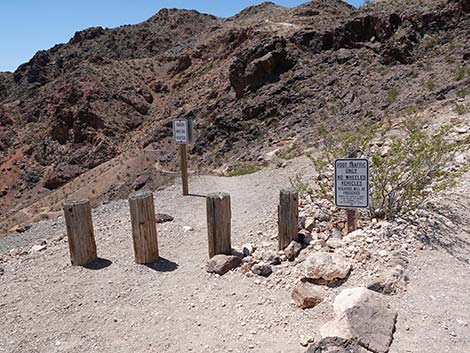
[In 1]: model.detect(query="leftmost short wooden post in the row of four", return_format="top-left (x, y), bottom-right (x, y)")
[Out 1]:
top-left (64, 199), bottom-right (98, 266)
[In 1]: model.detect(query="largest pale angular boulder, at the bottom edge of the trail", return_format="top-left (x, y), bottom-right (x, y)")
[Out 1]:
top-left (320, 287), bottom-right (397, 353)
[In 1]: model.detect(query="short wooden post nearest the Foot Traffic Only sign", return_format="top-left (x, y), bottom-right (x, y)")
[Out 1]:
top-left (278, 189), bottom-right (299, 250)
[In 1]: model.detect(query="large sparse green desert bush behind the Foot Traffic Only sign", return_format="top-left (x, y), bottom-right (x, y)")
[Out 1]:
top-left (291, 116), bottom-right (470, 218)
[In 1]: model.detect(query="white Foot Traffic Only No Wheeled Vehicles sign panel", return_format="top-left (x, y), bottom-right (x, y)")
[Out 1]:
top-left (335, 158), bottom-right (369, 208)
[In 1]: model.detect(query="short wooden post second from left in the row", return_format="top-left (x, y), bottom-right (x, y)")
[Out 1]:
top-left (129, 191), bottom-right (158, 264)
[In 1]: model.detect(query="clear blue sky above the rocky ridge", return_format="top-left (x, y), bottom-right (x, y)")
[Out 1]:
top-left (0, 0), bottom-right (363, 71)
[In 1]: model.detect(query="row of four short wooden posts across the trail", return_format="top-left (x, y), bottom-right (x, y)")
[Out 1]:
top-left (64, 190), bottom-right (299, 266)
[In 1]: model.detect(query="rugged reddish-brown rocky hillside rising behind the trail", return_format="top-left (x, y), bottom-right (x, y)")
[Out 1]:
top-left (0, 0), bottom-right (470, 232)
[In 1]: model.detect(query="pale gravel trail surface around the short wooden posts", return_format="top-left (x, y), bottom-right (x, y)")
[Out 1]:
top-left (0, 158), bottom-right (470, 353)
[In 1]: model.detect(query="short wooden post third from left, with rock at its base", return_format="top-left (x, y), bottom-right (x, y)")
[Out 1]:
top-left (206, 192), bottom-right (232, 258)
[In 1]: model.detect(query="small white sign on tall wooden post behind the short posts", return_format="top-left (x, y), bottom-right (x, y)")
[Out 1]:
top-left (173, 119), bottom-right (193, 196)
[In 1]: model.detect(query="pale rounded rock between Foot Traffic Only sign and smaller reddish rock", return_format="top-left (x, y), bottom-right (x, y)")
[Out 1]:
top-left (303, 252), bottom-right (351, 282)
